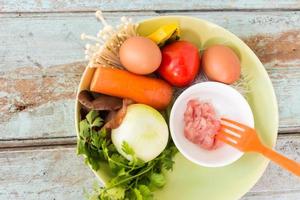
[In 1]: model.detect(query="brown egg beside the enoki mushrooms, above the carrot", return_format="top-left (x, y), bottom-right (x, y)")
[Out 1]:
top-left (119, 36), bottom-right (161, 74)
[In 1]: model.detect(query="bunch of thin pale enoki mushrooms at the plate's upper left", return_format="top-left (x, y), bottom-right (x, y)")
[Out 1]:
top-left (81, 10), bottom-right (138, 68)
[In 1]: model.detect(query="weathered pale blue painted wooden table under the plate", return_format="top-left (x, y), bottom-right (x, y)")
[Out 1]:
top-left (0, 0), bottom-right (300, 200)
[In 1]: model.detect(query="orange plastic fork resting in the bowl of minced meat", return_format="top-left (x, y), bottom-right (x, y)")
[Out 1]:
top-left (216, 118), bottom-right (300, 176)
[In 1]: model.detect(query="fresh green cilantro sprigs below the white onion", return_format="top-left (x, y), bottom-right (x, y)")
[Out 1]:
top-left (77, 111), bottom-right (177, 200)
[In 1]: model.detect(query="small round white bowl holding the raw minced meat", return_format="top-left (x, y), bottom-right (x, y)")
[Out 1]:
top-left (169, 82), bottom-right (254, 167)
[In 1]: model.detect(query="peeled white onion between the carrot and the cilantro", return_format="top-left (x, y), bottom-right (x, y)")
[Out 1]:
top-left (111, 104), bottom-right (169, 162)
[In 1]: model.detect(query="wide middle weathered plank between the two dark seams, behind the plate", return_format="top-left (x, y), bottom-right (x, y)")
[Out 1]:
top-left (0, 12), bottom-right (300, 140)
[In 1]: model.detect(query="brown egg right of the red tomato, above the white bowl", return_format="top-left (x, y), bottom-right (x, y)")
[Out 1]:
top-left (202, 45), bottom-right (241, 84)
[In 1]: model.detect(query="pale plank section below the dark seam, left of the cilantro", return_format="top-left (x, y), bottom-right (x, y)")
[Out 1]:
top-left (0, 147), bottom-right (96, 200)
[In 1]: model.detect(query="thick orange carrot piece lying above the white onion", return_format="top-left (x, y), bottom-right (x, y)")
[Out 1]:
top-left (90, 67), bottom-right (173, 109)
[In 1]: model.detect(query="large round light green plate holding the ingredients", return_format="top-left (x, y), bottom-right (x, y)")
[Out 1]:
top-left (75, 16), bottom-right (278, 200)
